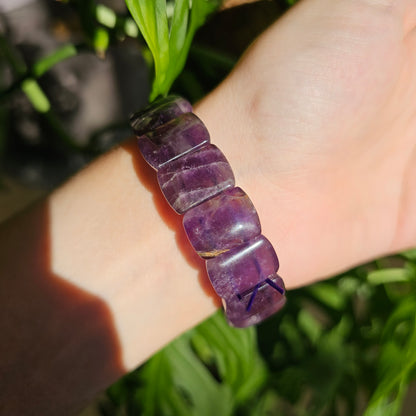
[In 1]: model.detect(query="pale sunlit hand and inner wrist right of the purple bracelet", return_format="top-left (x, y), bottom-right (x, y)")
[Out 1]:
top-left (199, 0), bottom-right (416, 287)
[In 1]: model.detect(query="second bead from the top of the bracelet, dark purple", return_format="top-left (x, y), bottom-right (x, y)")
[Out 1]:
top-left (138, 113), bottom-right (209, 170)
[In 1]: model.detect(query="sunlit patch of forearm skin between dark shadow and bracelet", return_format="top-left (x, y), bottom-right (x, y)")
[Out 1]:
top-left (51, 141), bottom-right (218, 369)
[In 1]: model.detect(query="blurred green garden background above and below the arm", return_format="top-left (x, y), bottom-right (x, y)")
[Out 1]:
top-left (0, 0), bottom-right (416, 416)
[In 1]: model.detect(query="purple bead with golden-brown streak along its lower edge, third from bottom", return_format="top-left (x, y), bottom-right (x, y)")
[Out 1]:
top-left (183, 188), bottom-right (261, 258)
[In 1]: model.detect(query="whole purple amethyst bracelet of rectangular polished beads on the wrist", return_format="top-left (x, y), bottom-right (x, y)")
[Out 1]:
top-left (130, 96), bottom-right (286, 327)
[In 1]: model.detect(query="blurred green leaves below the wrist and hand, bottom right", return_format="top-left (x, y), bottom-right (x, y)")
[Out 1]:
top-left (101, 255), bottom-right (416, 416)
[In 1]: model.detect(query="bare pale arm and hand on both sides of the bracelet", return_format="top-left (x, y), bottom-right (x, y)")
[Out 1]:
top-left (0, 0), bottom-right (416, 415)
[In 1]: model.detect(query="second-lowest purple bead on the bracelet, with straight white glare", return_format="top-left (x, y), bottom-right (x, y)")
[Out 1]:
top-left (206, 235), bottom-right (279, 299)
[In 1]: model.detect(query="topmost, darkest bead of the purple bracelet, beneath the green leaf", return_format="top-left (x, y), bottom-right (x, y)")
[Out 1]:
top-left (130, 95), bottom-right (192, 136)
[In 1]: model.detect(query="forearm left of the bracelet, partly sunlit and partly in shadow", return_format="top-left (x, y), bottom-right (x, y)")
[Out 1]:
top-left (0, 145), bottom-right (215, 415)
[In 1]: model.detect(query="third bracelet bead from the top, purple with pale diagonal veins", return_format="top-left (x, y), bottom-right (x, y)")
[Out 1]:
top-left (157, 144), bottom-right (234, 214)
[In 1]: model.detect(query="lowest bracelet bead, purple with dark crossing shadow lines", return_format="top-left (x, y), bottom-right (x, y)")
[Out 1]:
top-left (223, 275), bottom-right (286, 328)
